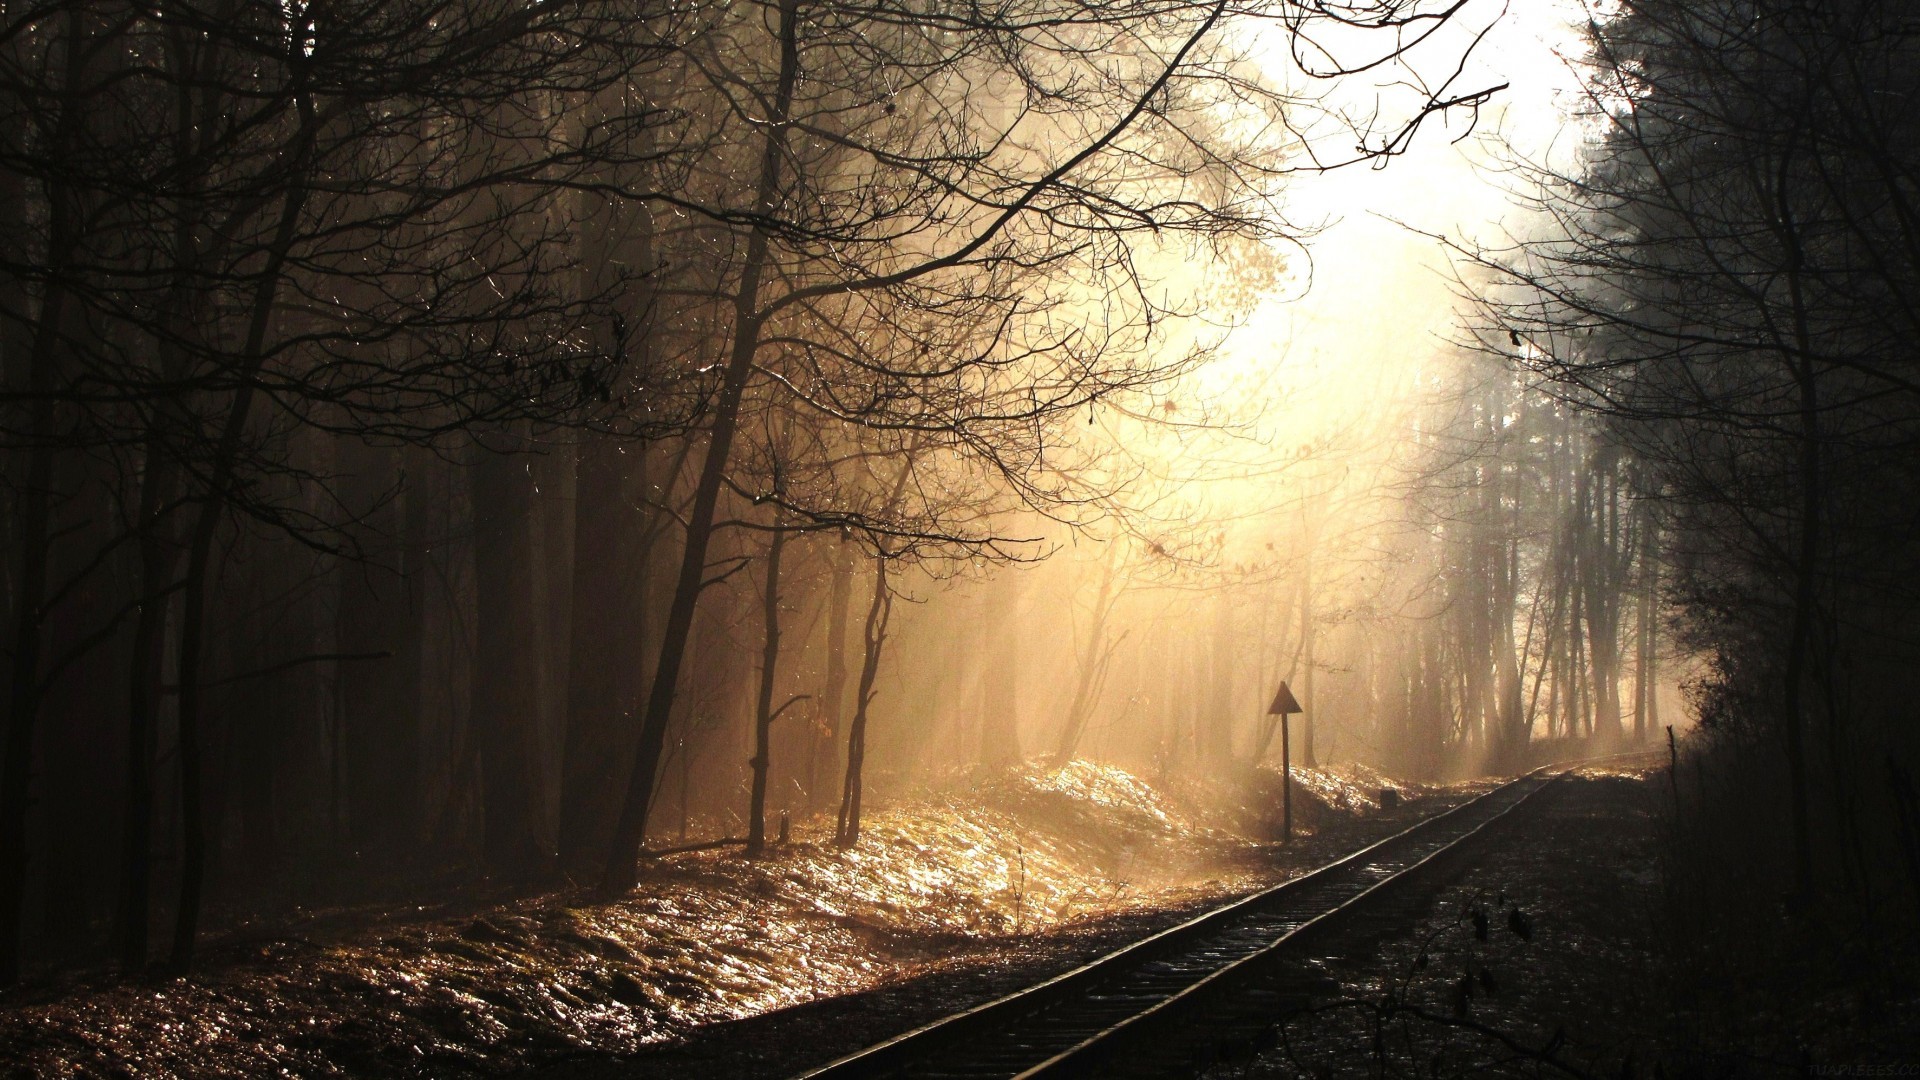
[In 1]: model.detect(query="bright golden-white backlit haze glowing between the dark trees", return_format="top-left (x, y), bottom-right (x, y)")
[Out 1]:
top-left (840, 4), bottom-right (1672, 791)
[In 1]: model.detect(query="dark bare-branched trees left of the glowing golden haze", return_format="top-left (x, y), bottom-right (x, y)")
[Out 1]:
top-left (0, 0), bottom-right (1489, 980)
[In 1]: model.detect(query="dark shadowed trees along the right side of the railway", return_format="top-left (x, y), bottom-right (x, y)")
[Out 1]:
top-left (1461, 0), bottom-right (1920, 936)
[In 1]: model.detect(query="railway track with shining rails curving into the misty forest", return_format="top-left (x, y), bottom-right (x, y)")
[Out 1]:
top-left (797, 763), bottom-right (1651, 1080)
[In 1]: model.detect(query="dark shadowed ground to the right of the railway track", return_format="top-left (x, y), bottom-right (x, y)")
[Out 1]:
top-left (1210, 769), bottom-right (1920, 1080)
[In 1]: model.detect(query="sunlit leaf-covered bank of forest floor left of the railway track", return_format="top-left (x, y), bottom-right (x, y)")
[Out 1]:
top-left (0, 763), bottom-right (1451, 1078)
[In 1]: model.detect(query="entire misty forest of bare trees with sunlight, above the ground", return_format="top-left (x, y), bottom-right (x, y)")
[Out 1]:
top-left (0, 0), bottom-right (1920, 1068)
